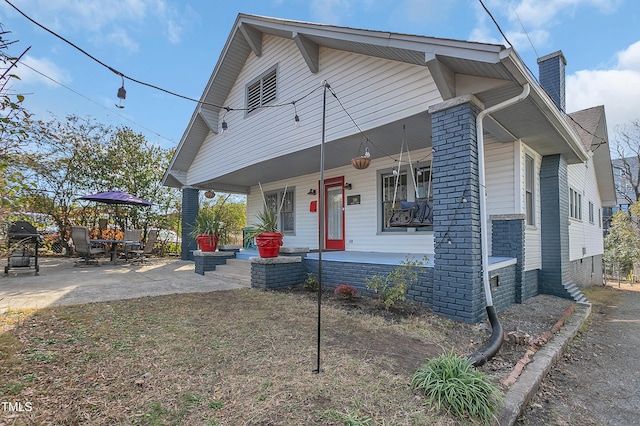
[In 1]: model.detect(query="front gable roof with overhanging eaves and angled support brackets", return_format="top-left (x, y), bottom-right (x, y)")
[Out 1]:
top-left (163, 14), bottom-right (588, 192)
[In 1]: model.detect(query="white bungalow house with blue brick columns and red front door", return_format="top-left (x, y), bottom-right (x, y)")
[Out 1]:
top-left (164, 14), bottom-right (616, 322)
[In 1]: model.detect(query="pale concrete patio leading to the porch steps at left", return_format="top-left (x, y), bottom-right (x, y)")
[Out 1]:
top-left (0, 258), bottom-right (242, 313)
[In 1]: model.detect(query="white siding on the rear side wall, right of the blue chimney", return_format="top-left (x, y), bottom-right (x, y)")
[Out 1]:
top-left (566, 160), bottom-right (604, 261)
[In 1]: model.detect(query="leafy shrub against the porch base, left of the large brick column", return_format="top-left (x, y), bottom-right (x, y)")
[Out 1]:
top-left (365, 258), bottom-right (426, 309)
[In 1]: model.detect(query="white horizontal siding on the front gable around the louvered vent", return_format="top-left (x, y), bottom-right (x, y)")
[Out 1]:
top-left (188, 36), bottom-right (441, 182)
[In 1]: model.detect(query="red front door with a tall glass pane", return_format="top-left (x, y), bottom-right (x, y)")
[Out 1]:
top-left (324, 176), bottom-right (345, 250)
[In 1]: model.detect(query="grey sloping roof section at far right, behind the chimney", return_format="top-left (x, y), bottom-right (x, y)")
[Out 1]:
top-left (567, 105), bottom-right (617, 207)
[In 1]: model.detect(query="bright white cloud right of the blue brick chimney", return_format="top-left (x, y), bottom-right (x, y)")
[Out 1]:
top-left (566, 41), bottom-right (640, 136)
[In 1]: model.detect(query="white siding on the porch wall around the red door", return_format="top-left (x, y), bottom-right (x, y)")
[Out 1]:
top-left (247, 148), bottom-right (433, 254)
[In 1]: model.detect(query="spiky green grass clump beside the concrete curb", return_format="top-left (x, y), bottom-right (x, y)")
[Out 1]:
top-left (411, 352), bottom-right (502, 424)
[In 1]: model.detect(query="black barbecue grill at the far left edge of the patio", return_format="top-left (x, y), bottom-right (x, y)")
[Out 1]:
top-left (4, 220), bottom-right (42, 275)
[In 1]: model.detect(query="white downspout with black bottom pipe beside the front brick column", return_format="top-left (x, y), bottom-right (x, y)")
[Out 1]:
top-left (467, 83), bottom-right (531, 367)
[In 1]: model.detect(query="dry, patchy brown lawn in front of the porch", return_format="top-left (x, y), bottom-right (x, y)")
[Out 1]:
top-left (0, 289), bottom-right (570, 425)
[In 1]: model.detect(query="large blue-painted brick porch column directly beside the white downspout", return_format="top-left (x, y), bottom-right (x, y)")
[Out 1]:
top-left (429, 95), bottom-right (486, 323)
